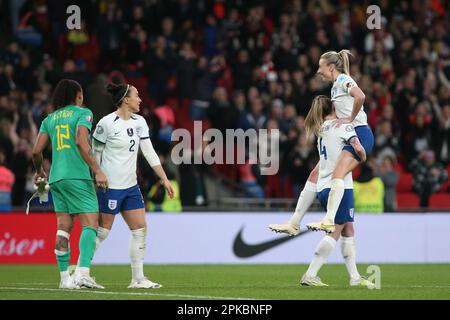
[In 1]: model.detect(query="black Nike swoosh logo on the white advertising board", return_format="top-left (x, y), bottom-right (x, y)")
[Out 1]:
top-left (233, 227), bottom-right (310, 258)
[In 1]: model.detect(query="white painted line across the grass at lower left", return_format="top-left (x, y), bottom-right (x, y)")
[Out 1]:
top-left (0, 287), bottom-right (256, 300)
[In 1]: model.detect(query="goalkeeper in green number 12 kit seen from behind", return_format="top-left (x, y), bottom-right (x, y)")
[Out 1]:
top-left (33, 79), bottom-right (108, 289)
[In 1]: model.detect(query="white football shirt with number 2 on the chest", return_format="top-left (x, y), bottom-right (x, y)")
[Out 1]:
top-left (93, 112), bottom-right (158, 189)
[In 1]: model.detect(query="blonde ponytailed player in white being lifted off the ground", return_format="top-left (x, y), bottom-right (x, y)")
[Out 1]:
top-left (270, 50), bottom-right (374, 235)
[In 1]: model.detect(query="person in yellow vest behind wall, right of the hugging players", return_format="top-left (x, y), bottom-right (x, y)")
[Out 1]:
top-left (353, 160), bottom-right (385, 213)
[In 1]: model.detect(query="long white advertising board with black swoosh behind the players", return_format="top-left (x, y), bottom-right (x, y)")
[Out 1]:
top-left (93, 212), bottom-right (450, 264)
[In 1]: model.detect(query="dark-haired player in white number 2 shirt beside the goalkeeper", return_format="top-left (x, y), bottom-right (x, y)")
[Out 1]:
top-left (89, 84), bottom-right (173, 288)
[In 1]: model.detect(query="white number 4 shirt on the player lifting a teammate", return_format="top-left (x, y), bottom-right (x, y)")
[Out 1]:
top-left (317, 120), bottom-right (357, 192)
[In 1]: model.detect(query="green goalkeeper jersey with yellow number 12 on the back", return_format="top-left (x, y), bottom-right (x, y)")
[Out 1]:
top-left (39, 105), bottom-right (93, 183)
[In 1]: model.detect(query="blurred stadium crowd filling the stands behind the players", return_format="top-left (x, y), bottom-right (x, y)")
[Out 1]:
top-left (0, 0), bottom-right (450, 211)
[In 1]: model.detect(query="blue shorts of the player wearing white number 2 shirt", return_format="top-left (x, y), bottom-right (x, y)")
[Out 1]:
top-left (97, 185), bottom-right (145, 214)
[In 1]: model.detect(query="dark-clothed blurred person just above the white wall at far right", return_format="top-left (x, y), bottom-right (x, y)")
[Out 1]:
top-left (411, 150), bottom-right (448, 207)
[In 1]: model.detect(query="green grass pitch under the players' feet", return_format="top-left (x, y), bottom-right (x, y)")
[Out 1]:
top-left (0, 264), bottom-right (450, 300)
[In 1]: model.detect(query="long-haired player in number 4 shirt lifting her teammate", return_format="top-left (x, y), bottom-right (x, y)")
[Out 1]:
top-left (301, 96), bottom-right (374, 288)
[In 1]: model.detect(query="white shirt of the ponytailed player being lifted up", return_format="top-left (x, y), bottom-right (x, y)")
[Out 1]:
top-left (331, 73), bottom-right (367, 127)
